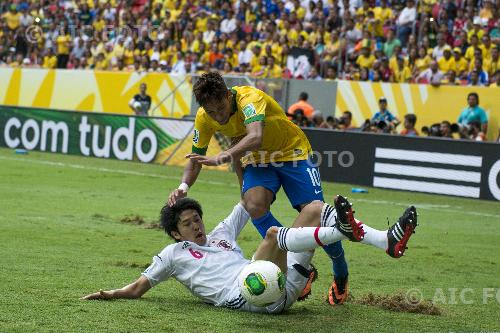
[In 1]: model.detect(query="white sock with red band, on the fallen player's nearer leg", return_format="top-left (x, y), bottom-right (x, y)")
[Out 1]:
top-left (278, 227), bottom-right (346, 252)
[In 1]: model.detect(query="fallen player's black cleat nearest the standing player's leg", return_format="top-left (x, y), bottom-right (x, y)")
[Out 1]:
top-left (334, 195), bottom-right (365, 242)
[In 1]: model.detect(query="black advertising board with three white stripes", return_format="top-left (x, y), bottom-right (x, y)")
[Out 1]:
top-left (305, 129), bottom-right (500, 200)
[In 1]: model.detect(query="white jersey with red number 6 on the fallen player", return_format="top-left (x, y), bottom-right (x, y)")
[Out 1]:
top-left (142, 203), bottom-right (250, 306)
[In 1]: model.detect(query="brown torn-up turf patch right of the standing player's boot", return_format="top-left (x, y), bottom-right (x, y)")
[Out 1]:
top-left (354, 292), bottom-right (442, 316)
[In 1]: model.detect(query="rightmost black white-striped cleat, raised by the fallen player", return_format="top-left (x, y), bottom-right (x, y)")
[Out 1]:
top-left (386, 206), bottom-right (418, 258)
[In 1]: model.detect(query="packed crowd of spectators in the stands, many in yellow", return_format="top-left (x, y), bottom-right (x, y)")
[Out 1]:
top-left (0, 0), bottom-right (500, 87)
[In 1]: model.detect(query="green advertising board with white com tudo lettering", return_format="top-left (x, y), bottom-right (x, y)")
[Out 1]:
top-left (0, 106), bottom-right (228, 170)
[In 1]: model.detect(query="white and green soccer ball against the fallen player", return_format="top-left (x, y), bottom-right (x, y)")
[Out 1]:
top-left (238, 260), bottom-right (286, 306)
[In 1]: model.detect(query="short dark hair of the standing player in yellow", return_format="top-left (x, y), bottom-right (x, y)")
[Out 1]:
top-left (193, 72), bottom-right (227, 106)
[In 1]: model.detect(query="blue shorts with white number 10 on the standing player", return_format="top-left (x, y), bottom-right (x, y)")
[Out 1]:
top-left (243, 160), bottom-right (324, 211)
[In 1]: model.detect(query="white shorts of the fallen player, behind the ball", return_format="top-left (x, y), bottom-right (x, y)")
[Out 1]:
top-left (224, 251), bottom-right (314, 313)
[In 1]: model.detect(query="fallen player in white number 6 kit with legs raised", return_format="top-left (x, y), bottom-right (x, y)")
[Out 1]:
top-left (82, 196), bottom-right (417, 313)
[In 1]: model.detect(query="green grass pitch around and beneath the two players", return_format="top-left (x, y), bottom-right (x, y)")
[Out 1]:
top-left (0, 149), bottom-right (500, 332)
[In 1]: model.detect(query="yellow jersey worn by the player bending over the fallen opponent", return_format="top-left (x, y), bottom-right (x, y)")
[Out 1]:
top-left (192, 86), bottom-right (312, 165)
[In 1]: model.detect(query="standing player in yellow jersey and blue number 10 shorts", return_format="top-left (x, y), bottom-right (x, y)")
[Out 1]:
top-left (168, 72), bottom-right (356, 305)
